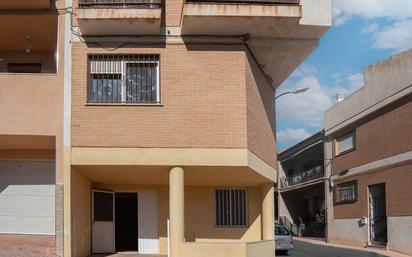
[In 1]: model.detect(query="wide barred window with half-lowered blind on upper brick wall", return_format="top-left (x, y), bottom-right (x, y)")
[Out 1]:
top-left (88, 55), bottom-right (160, 104)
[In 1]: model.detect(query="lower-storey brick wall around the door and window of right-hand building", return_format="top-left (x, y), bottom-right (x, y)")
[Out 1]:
top-left (334, 163), bottom-right (412, 219)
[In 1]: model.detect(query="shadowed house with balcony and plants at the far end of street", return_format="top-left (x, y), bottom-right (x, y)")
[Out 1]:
top-left (276, 131), bottom-right (325, 237)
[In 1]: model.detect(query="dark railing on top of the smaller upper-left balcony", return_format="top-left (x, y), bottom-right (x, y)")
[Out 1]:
top-left (79, 0), bottom-right (162, 8)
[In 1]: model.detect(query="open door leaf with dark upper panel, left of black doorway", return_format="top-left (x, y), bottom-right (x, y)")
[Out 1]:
top-left (92, 190), bottom-right (115, 253)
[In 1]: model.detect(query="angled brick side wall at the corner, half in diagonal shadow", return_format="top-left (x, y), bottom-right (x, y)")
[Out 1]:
top-left (246, 53), bottom-right (276, 167)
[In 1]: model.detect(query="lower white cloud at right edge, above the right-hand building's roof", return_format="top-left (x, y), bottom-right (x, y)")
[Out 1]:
top-left (373, 19), bottom-right (412, 51)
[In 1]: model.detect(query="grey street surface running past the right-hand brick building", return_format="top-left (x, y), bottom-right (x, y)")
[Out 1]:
top-left (276, 238), bottom-right (408, 257)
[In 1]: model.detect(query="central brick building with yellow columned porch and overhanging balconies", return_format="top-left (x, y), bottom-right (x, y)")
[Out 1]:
top-left (65, 0), bottom-right (331, 257)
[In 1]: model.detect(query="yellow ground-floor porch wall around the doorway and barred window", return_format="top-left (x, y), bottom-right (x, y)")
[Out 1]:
top-left (72, 180), bottom-right (261, 257)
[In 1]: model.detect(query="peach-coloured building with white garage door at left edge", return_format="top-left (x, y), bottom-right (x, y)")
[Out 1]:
top-left (0, 0), bottom-right (66, 256)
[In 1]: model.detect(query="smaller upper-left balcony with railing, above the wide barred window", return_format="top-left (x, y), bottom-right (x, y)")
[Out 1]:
top-left (76, 0), bottom-right (162, 36)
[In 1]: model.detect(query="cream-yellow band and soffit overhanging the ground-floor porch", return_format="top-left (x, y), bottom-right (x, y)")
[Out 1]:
top-left (71, 147), bottom-right (276, 186)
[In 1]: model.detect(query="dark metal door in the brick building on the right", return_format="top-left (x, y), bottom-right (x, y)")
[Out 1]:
top-left (369, 184), bottom-right (387, 245)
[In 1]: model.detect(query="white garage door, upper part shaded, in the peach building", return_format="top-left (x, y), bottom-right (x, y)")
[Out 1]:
top-left (0, 161), bottom-right (55, 235)
